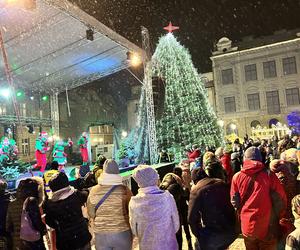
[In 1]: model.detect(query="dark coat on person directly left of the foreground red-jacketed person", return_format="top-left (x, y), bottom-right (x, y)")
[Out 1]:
top-left (188, 177), bottom-right (237, 250)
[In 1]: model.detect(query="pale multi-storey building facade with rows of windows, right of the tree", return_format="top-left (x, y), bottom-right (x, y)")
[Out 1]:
top-left (211, 31), bottom-right (300, 137)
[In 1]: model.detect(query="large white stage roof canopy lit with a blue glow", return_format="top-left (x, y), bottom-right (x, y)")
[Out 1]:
top-left (0, 0), bottom-right (143, 93)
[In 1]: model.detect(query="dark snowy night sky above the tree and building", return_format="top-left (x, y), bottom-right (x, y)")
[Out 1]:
top-left (71, 0), bottom-right (300, 72)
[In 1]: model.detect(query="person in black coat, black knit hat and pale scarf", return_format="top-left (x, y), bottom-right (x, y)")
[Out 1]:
top-left (44, 172), bottom-right (92, 250)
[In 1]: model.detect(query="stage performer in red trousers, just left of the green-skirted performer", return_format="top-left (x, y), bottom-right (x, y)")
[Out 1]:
top-left (34, 131), bottom-right (50, 172)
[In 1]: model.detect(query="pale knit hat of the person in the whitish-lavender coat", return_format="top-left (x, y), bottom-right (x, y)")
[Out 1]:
top-left (132, 165), bottom-right (159, 188)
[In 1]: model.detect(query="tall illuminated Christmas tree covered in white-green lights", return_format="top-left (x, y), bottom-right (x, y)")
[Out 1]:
top-left (153, 27), bottom-right (223, 154)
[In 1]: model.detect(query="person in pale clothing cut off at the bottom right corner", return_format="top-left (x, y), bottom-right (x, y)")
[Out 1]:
top-left (285, 194), bottom-right (300, 250)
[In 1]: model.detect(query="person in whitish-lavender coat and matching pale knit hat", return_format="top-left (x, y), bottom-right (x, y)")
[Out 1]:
top-left (129, 165), bottom-right (180, 250)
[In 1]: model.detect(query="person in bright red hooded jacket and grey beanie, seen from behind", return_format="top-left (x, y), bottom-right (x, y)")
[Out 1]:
top-left (230, 147), bottom-right (287, 250)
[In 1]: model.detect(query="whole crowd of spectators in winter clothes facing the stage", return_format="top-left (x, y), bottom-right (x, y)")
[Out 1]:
top-left (0, 136), bottom-right (300, 250)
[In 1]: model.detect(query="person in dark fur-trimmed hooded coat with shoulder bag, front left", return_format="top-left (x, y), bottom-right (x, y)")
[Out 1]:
top-left (6, 177), bottom-right (46, 250)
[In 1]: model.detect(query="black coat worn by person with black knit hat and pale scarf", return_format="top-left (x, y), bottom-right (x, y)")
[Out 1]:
top-left (44, 191), bottom-right (92, 250)
